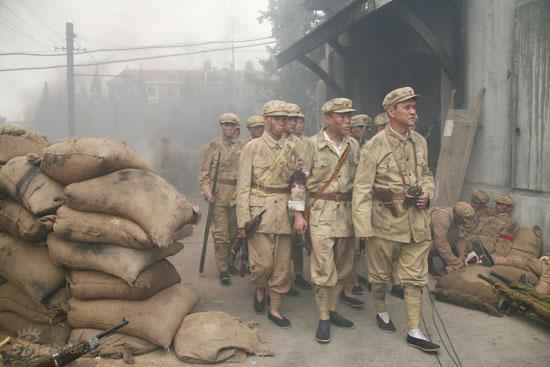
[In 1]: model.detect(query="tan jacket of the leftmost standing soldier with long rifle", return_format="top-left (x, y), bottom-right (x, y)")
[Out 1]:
top-left (199, 137), bottom-right (244, 206)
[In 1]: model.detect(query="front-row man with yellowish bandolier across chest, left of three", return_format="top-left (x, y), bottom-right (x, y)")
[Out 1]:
top-left (237, 100), bottom-right (303, 328)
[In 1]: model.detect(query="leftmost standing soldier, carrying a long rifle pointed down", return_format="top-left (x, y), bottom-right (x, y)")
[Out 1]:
top-left (199, 113), bottom-right (243, 285)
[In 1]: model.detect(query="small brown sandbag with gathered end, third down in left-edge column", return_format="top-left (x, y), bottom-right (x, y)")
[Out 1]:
top-left (0, 199), bottom-right (53, 242)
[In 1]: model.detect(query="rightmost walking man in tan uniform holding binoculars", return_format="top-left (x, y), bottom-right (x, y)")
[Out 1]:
top-left (353, 87), bottom-right (439, 352)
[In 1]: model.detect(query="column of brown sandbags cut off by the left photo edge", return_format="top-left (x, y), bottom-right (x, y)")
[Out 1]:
top-left (0, 133), bottom-right (70, 345)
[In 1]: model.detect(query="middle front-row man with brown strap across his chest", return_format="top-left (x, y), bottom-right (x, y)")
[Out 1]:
top-left (295, 98), bottom-right (359, 343)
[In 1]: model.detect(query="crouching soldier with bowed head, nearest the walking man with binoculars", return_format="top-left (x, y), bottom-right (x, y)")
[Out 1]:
top-left (430, 201), bottom-right (476, 276)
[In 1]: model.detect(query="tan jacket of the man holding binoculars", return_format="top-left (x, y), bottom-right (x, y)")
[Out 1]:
top-left (353, 125), bottom-right (435, 243)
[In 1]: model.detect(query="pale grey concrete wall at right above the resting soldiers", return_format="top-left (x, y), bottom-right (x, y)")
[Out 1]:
top-left (462, 0), bottom-right (550, 251)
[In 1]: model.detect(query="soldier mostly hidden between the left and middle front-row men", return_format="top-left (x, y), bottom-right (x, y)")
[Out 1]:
top-left (286, 103), bottom-right (313, 298)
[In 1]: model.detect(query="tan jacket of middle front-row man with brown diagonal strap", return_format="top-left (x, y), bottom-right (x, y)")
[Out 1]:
top-left (304, 131), bottom-right (359, 237)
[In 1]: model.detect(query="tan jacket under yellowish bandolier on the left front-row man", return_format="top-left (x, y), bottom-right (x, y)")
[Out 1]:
top-left (237, 131), bottom-right (299, 235)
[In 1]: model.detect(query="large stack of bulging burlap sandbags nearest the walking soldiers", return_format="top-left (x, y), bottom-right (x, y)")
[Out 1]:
top-left (37, 138), bottom-right (200, 361)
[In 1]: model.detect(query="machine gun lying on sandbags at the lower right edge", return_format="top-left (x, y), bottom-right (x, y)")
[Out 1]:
top-left (477, 271), bottom-right (550, 326)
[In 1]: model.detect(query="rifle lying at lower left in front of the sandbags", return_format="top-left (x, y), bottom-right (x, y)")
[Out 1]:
top-left (34, 319), bottom-right (128, 367)
